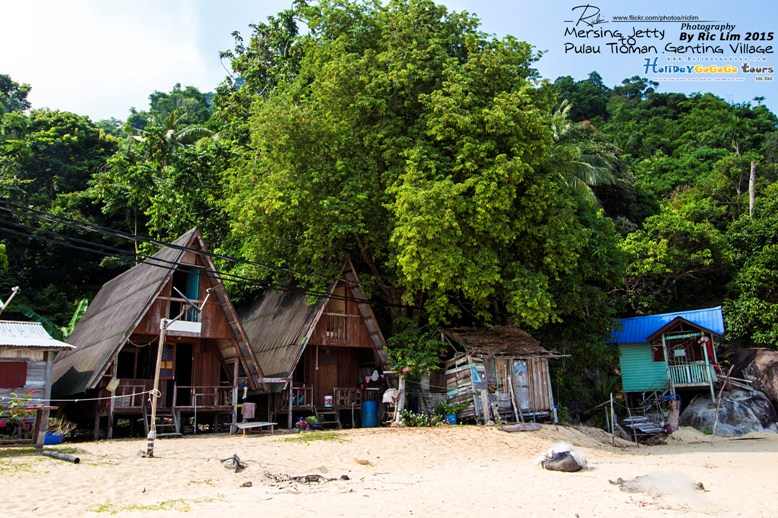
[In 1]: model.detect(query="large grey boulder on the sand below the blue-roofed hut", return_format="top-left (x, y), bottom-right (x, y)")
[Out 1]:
top-left (681, 390), bottom-right (778, 437)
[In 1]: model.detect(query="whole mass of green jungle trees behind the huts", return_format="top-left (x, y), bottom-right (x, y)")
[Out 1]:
top-left (0, 0), bottom-right (778, 414)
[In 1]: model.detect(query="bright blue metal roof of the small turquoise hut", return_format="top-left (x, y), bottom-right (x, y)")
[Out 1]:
top-left (608, 306), bottom-right (724, 344)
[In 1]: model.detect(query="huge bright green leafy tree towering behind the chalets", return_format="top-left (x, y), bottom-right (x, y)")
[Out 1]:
top-left (217, 0), bottom-right (616, 334)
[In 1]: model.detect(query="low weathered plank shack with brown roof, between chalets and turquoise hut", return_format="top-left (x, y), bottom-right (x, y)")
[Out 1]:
top-left (443, 326), bottom-right (560, 421)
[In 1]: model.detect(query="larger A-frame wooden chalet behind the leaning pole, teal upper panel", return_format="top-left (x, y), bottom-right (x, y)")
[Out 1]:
top-left (53, 229), bottom-right (262, 438)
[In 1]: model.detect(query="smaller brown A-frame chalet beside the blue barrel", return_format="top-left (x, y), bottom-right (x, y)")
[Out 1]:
top-left (239, 260), bottom-right (386, 428)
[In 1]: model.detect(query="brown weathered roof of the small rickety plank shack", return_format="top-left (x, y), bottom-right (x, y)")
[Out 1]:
top-left (443, 326), bottom-right (558, 358)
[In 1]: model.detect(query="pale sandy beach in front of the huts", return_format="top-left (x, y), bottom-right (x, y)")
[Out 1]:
top-left (0, 425), bottom-right (778, 517)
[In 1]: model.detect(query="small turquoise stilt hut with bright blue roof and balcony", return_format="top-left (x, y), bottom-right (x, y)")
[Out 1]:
top-left (609, 306), bottom-right (724, 399)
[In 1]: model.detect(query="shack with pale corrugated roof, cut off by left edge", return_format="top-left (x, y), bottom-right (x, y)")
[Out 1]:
top-left (0, 320), bottom-right (73, 442)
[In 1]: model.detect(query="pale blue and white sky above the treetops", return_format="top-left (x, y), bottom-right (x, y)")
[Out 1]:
top-left (0, 0), bottom-right (778, 121)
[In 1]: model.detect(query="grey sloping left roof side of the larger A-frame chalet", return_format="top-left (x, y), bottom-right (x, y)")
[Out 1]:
top-left (52, 229), bottom-right (197, 397)
